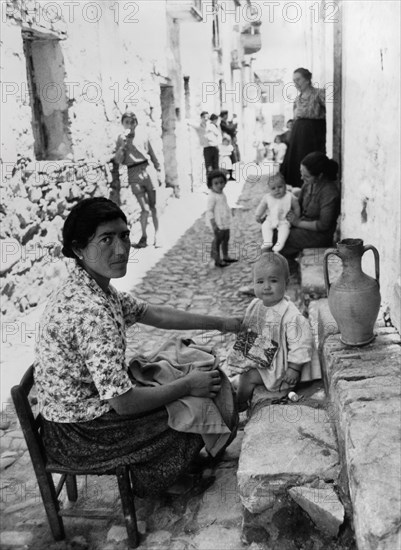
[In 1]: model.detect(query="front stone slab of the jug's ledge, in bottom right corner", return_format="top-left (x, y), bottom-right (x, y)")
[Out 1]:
top-left (340, 398), bottom-right (401, 550)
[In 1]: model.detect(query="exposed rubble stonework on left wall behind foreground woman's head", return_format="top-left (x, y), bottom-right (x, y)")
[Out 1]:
top-left (0, 161), bottom-right (109, 319)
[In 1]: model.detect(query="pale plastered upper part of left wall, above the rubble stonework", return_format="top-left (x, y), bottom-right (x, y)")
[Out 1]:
top-left (2, 0), bottom-right (172, 166)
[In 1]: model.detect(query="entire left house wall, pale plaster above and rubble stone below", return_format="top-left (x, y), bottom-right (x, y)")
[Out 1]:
top-left (0, 0), bottom-right (180, 318)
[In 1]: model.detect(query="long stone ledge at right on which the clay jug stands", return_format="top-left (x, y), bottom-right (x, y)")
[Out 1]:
top-left (319, 300), bottom-right (401, 550)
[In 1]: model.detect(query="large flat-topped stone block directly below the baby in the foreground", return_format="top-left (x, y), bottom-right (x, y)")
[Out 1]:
top-left (237, 404), bottom-right (339, 513)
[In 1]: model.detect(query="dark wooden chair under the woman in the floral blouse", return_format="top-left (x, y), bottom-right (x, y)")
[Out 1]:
top-left (11, 365), bottom-right (139, 548)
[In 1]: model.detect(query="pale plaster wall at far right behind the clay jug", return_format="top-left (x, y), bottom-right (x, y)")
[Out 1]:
top-left (341, 1), bottom-right (401, 330)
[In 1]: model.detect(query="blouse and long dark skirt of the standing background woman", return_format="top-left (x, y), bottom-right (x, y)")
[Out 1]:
top-left (280, 88), bottom-right (326, 187)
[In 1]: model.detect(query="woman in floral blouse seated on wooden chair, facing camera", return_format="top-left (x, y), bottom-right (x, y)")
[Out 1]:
top-left (34, 198), bottom-right (240, 496)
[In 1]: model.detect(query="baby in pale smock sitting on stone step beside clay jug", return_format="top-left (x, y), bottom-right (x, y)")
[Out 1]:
top-left (227, 252), bottom-right (314, 411)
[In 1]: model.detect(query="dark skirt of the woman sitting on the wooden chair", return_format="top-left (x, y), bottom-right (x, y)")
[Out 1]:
top-left (42, 408), bottom-right (203, 497)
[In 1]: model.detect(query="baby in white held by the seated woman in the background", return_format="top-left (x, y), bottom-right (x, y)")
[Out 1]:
top-left (255, 174), bottom-right (301, 252)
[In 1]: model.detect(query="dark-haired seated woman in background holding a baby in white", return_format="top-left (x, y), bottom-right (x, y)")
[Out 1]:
top-left (281, 152), bottom-right (340, 261)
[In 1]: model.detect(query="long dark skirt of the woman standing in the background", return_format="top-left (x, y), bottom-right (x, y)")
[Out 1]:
top-left (280, 118), bottom-right (326, 187)
